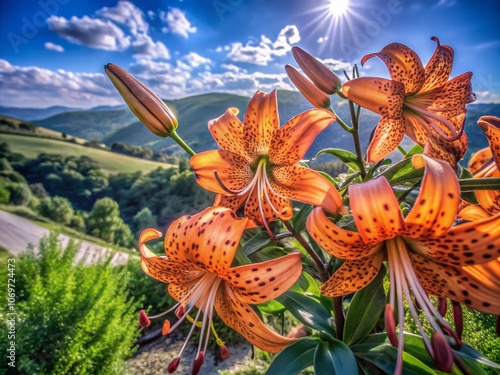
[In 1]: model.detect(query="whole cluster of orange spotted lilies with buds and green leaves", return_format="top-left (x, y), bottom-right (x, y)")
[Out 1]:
top-left (106, 38), bottom-right (500, 374)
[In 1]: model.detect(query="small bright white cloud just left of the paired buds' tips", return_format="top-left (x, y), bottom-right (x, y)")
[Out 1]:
top-left (224, 25), bottom-right (300, 65)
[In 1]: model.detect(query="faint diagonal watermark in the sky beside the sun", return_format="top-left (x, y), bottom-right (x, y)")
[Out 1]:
top-left (340, 0), bottom-right (403, 60)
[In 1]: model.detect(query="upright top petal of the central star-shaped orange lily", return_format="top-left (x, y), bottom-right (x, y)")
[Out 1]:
top-left (243, 90), bottom-right (279, 159)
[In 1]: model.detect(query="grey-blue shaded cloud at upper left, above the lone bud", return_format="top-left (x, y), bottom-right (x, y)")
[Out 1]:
top-left (47, 16), bottom-right (130, 51)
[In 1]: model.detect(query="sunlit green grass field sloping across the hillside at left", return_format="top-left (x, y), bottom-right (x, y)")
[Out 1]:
top-left (0, 133), bottom-right (175, 174)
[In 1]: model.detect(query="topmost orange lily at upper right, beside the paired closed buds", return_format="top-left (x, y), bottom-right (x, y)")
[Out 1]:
top-left (342, 37), bottom-right (475, 166)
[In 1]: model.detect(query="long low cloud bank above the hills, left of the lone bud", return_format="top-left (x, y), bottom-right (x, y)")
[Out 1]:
top-left (0, 59), bottom-right (121, 107)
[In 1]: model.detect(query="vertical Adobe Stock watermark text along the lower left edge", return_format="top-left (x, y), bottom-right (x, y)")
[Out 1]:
top-left (5, 258), bottom-right (17, 367)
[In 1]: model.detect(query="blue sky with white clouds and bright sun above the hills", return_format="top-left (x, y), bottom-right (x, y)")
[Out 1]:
top-left (0, 0), bottom-right (500, 108)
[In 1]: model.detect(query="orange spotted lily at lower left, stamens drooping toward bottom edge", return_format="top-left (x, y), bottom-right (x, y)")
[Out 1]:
top-left (139, 207), bottom-right (302, 374)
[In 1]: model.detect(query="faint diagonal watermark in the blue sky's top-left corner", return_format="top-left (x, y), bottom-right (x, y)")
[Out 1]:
top-left (7, 0), bottom-right (71, 53)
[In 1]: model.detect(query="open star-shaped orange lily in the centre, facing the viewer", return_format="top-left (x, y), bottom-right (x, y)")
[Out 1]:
top-left (190, 90), bottom-right (342, 233)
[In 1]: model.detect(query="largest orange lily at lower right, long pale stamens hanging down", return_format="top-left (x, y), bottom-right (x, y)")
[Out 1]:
top-left (307, 155), bottom-right (500, 373)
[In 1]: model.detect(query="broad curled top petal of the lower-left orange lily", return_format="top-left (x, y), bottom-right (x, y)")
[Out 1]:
top-left (165, 207), bottom-right (247, 276)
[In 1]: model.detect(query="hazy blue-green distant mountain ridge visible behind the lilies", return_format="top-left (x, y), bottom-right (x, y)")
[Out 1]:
top-left (0, 90), bottom-right (500, 161)
